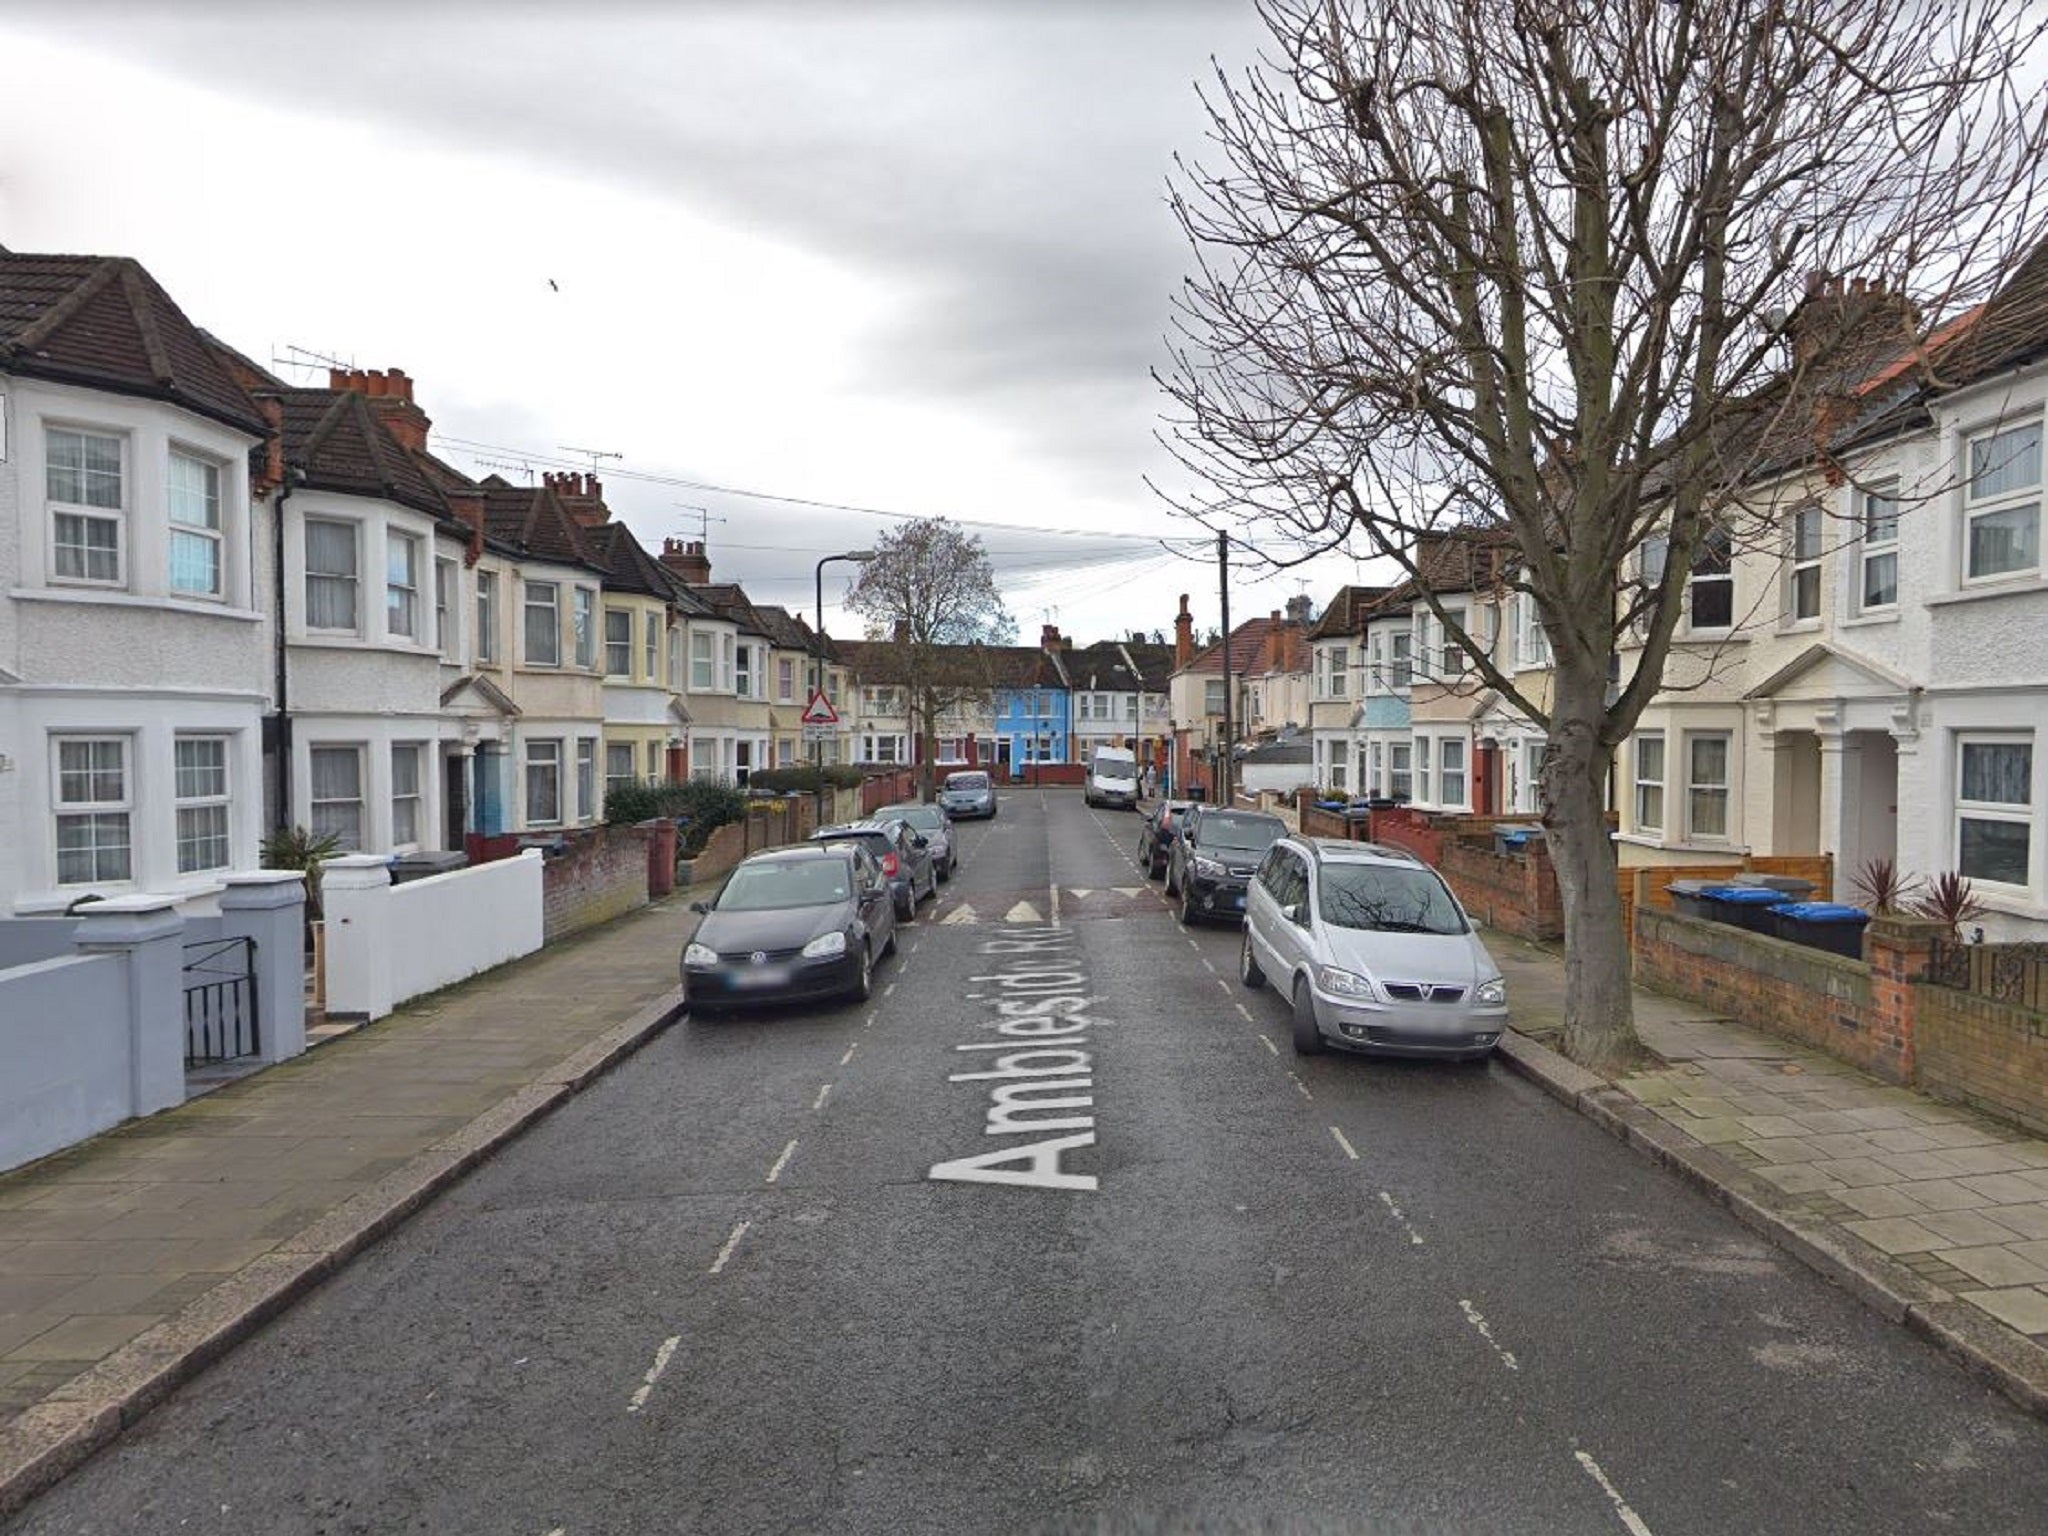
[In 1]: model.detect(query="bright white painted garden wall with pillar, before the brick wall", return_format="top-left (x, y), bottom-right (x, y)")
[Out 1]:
top-left (322, 850), bottom-right (543, 1018)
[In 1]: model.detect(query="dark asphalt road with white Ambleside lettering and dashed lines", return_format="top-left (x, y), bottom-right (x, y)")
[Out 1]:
top-left (8, 793), bottom-right (2048, 1536)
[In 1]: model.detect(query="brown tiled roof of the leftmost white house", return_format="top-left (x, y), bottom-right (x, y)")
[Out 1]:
top-left (0, 248), bottom-right (264, 436)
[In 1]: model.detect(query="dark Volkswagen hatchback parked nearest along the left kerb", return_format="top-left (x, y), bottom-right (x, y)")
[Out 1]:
top-left (682, 844), bottom-right (895, 1014)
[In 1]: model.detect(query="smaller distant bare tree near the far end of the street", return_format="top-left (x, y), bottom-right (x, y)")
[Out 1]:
top-left (846, 518), bottom-right (1016, 797)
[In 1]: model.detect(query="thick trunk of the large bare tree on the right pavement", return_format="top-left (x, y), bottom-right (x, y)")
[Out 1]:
top-left (1542, 657), bottom-right (1640, 1073)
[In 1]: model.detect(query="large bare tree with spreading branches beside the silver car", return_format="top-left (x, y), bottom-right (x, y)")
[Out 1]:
top-left (1161, 0), bottom-right (2042, 1065)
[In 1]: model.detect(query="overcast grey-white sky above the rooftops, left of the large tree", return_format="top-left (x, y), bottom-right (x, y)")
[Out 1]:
top-left (0, 0), bottom-right (1354, 641)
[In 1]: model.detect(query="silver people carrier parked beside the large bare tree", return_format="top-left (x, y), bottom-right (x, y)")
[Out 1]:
top-left (1239, 838), bottom-right (1507, 1059)
